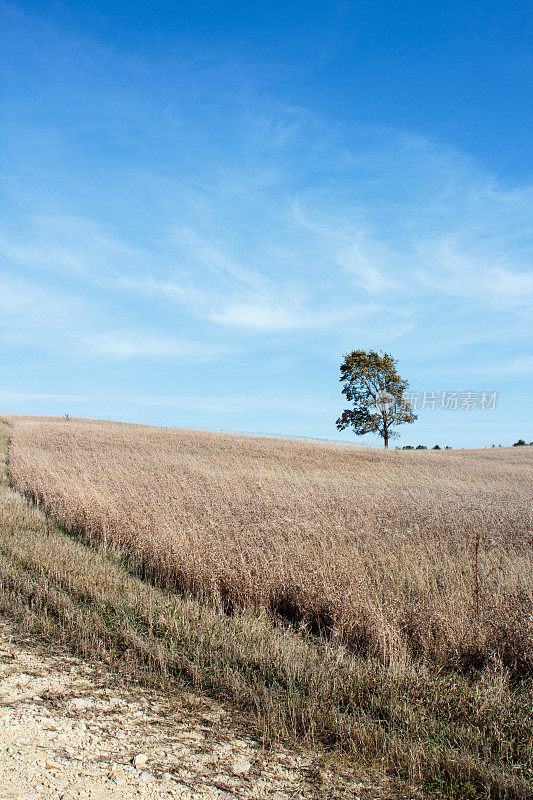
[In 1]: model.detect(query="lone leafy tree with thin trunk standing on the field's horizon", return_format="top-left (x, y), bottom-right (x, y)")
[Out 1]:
top-left (337, 350), bottom-right (417, 448)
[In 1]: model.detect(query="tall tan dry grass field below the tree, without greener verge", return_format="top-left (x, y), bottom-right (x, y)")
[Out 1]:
top-left (9, 418), bottom-right (533, 673)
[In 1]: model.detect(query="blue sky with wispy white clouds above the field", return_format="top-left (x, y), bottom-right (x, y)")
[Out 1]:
top-left (0, 2), bottom-right (533, 447)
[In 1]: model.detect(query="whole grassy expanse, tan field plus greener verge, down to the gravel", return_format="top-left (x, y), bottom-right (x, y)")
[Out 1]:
top-left (0, 418), bottom-right (533, 799)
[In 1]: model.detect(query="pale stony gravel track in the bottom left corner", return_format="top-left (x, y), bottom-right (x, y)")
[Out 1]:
top-left (0, 620), bottom-right (404, 800)
